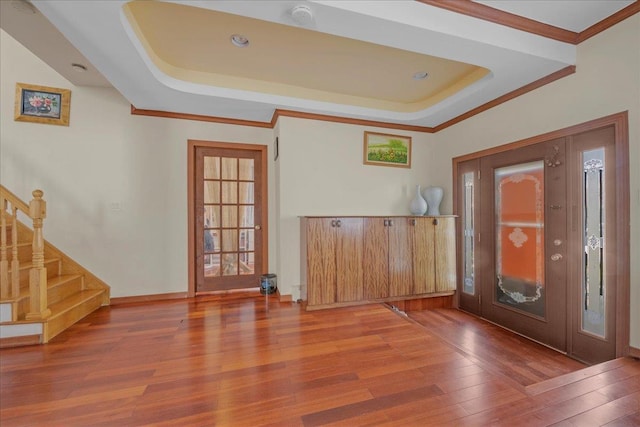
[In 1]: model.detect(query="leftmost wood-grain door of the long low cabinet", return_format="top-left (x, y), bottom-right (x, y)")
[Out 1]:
top-left (307, 218), bottom-right (336, 305)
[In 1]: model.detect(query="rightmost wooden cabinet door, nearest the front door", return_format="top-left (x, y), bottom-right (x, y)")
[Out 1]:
top-left (435, 218), bottom-right (456, 292)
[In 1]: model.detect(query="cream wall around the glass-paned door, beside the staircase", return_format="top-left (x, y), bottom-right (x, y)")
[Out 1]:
top-left (0, 31), bottom-right (276, 297)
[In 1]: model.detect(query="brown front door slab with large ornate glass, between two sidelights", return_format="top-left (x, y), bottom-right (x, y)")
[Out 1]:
top-left (478, 138), bottom-right (567, 351)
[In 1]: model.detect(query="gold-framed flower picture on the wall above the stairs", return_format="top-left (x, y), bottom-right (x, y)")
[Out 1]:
top-left (14, 83), bottom-right (71, 126)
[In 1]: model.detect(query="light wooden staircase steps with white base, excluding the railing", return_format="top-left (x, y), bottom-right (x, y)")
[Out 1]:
top-left (0, 190), bottom-right (110, 348)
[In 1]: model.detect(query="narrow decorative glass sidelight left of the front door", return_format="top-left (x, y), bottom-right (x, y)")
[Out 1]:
top-left (462, 172), bottom-right (476, 295)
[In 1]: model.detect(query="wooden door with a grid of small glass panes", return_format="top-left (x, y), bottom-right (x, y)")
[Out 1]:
top-left (196, 148), bottom-right (262, 291)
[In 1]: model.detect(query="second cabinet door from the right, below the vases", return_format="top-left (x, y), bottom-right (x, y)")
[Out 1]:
top-left (412, 218), bottom-right (436, 295)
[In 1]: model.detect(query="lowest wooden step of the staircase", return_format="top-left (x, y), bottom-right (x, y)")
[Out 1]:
top-left (45, 289), bottom-right (106, 341)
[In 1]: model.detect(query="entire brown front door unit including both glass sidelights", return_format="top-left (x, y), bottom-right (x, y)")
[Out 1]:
top-left (456, 121), bottom-right (628, 363)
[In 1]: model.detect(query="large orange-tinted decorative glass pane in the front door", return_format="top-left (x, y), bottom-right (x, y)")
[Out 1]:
top-left (494, 160), bottom-right (546, 318)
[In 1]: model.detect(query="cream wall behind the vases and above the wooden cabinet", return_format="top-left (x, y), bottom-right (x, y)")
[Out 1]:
top-left (278, 117), bottom-right (438, 299)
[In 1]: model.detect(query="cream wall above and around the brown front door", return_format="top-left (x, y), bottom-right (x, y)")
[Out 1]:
top-left (431, 14), bottom-right (640, 348)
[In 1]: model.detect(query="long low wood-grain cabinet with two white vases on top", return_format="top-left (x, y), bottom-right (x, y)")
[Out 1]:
top-left (301, 216), bottom-right (456, 309)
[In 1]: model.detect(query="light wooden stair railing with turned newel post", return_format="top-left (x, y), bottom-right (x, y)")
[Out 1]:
top-left (0, 185), bottom-right (51, 320)
